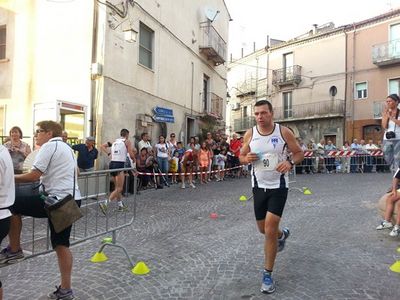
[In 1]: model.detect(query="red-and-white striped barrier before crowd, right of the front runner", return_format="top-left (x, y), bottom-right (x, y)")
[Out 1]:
top-left (296, 149), bottom-right (390, 174)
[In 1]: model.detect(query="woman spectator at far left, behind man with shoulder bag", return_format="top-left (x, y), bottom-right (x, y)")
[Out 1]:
top-left (4, 126), bottom-right (31, 174)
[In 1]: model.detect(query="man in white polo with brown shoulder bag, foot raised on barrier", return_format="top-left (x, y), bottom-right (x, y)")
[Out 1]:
top-left (0, 121), bottom-right (80, 300)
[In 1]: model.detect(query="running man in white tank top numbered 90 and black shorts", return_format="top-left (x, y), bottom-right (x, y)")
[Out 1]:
top-left (239, 100), bottom-right (304, 294)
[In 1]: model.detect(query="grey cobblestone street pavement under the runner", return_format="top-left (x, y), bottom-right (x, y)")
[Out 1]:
top-left (0, 173), bottom-right (400, 300)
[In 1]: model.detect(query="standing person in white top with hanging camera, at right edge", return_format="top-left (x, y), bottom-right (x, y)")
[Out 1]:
top-left (382, 94), bottom-right (400, 169)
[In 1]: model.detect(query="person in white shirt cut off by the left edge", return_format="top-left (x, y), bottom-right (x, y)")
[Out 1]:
top-left (0, 145), bottom-right (15, 299)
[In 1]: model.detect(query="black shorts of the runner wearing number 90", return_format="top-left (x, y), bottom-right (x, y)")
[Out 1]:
top-left (253, 187), bottom-right (288, 221)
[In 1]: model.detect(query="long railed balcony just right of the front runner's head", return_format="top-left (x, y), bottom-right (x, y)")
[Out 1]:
top-left (274, 100), bottom-right (346, 121)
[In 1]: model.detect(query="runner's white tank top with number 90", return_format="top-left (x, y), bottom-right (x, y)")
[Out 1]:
top-left (249, 123), bottom-right (289, 189)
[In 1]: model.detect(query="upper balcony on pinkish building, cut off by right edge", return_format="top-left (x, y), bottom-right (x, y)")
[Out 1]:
top-left (372, 40), bottom-right (400, 67)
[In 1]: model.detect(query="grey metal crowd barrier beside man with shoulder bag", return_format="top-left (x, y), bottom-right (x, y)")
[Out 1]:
top-left (3, 168), bottom-right (137, 266)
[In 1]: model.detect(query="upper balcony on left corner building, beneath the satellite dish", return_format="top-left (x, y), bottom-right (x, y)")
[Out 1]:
top-left (199, 22), bottom-right (226, 66)
